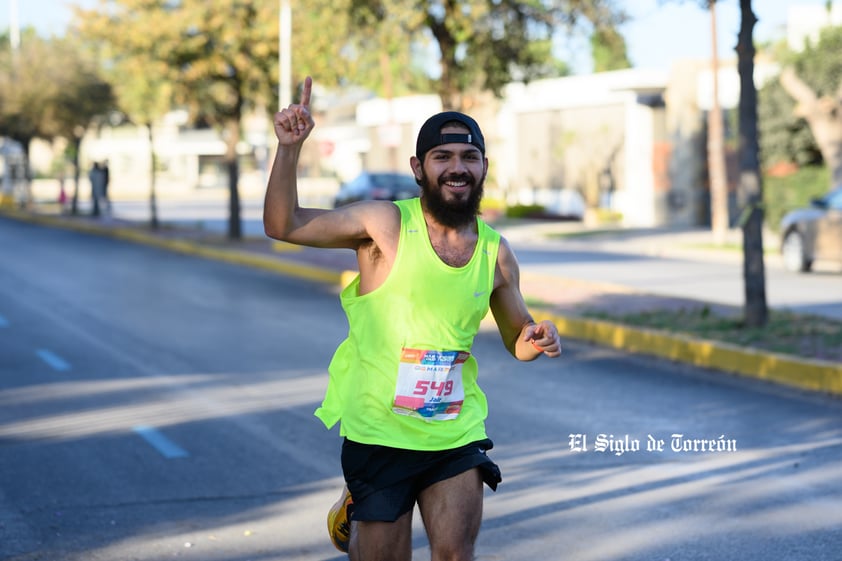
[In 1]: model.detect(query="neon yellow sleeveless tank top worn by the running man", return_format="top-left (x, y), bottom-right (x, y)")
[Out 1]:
top-left (315, 198), bottom-right (500, 450)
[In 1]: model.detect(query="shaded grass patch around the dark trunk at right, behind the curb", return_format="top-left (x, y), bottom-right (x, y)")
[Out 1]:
top-left (583, 306), bottom-right (842, 362)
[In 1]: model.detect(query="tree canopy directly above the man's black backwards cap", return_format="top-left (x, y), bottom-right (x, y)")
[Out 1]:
top-left (342, 0), bottom-right (625, 109)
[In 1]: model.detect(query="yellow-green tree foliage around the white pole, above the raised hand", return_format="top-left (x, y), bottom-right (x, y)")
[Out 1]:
top-left (70, 0), bottom-right (350, 129)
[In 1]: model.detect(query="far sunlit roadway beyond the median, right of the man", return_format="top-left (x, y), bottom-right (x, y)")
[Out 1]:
top-left (502, 232), bottom-right (842, 320)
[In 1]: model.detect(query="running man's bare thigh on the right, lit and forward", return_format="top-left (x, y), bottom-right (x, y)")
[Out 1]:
top-left (416, 468), bottom-right (482, 561)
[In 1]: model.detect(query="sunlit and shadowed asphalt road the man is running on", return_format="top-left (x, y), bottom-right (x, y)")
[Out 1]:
top-left (0, 219), bottom-right (842, 561)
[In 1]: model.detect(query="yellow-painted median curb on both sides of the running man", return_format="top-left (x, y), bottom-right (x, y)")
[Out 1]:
top-left (0, 209), bottom-right (842, 396)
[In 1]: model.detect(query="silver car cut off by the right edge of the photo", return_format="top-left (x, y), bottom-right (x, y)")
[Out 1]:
top-left (780, 185), bottom-right (842, 272)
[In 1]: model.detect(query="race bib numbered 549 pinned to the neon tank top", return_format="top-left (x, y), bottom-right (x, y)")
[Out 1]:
top-left (392, 348), bottom-right (471, 421)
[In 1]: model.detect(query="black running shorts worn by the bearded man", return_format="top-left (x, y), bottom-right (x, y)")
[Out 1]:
top-left (342, 438), bottom-right (501, 522)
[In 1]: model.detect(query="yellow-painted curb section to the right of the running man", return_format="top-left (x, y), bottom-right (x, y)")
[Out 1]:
top-left (532, 310), bottom-right (842, 395)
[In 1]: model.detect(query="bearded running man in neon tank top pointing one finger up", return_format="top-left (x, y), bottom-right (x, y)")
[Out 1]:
top-left (263, 77), bottom-right (561, 561)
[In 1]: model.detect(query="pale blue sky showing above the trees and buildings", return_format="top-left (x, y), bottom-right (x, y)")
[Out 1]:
top-left (0, 0), bottom-right (824, 71)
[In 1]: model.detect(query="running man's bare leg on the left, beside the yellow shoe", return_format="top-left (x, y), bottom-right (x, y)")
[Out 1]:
top-left (348, 510), bottom-right (412, 561)
